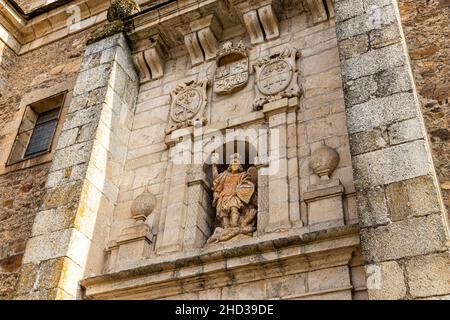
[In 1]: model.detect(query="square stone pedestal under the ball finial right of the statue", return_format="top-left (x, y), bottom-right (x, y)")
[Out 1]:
top-left (304, 179), bottom-right (345, 229)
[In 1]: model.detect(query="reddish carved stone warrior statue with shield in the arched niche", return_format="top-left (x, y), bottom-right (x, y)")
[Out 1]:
top-left (208, 153), bottom-right (258, 243)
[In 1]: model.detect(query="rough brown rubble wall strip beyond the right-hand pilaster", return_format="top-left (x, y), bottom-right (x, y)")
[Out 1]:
top-left (399, 1), bottom-right (450, 222)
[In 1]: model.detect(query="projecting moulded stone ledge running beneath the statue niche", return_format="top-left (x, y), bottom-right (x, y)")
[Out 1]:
top-left (81, 226), bottom-right (365, 300)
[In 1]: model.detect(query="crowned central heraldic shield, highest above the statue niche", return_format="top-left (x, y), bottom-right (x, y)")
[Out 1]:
top-left (214, 41), bottom-right (249, 94)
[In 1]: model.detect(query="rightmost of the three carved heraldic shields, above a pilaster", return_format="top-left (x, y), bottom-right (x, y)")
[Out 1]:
top-left (253, 49), bottom-right (301, 110)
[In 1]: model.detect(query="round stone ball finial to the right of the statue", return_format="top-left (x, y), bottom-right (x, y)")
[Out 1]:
top-left (309, 145), bottom-right (340, 180)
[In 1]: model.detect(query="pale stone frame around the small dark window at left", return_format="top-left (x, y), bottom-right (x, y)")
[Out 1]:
top-left (0, 81), bottom-right (74, 175)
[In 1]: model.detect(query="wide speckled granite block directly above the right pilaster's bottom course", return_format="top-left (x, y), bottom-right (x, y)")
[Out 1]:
top-left (361, 214), bottom-right (447, 263)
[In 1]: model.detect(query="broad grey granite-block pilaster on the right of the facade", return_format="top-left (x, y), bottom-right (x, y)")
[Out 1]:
top-left (334, 0), bottom-right (450, 299)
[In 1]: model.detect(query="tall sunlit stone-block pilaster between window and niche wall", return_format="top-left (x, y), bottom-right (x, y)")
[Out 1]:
top-left (17, 34), bottom-right (138, 299)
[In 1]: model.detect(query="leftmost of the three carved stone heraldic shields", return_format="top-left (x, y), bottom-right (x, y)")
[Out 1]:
top-left (166, 80), bottom-right (208, 134)
